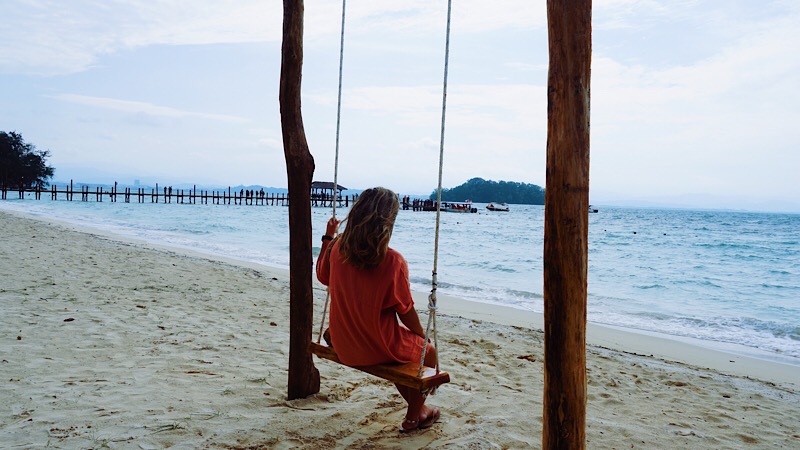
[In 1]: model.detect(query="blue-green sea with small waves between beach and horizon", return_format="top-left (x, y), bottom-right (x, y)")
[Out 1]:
top-left (0, 199), bottom-right (800, 366)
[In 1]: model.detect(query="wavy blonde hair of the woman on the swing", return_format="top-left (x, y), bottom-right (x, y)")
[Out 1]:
top-left (339, 187), bottom-right (400, 269)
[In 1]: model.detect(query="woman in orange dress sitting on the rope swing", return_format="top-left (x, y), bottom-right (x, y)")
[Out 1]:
top-left (317, 187), bottom-right (440, 431)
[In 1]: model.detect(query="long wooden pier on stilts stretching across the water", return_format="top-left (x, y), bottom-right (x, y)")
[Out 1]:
top-left (0, 180), bottom-right (357, 207)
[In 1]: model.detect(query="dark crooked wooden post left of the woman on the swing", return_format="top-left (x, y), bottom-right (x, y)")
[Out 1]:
top-left (278, 0), bottom-right (319, 400)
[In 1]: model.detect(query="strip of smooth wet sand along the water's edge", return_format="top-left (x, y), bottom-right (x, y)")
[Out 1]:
top-left (0, 210), bottom-right (800, 388)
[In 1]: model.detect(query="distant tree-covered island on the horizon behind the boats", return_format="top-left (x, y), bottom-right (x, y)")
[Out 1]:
top-left (429, 178), bottom-right (544, 205)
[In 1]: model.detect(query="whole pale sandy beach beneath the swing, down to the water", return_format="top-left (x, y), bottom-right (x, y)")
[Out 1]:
top-left (0, 211), bottom-right (800, 449)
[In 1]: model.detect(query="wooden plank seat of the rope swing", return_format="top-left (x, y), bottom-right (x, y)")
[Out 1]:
top-left (308, 342), bottom-right (450, 392)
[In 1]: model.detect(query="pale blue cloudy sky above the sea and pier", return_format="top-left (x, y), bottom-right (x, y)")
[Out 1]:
top-left (0, 0), bottom-right (800, 212)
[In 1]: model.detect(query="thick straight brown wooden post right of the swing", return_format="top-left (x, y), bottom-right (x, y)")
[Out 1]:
top-left (542, 0), bottom-right (592, 450)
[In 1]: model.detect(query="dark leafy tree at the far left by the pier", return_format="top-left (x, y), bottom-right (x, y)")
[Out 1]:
top-left (0, 131), bottom-right (55, 188)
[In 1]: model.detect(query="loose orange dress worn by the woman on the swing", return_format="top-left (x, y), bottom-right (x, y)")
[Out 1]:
top-left (317, 242), bottom-right (423, 366)
